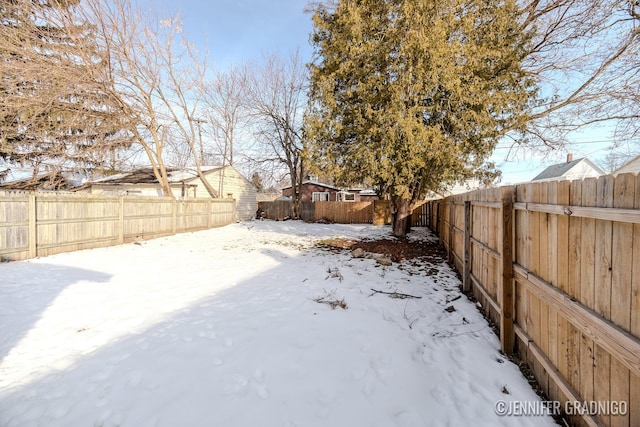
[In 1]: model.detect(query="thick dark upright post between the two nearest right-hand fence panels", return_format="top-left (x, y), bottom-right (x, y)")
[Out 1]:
top-left (500, 187), bottom-right (515, 354)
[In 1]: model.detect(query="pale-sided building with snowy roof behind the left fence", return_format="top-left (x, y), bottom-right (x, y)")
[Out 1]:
top-left (74, 166), bottom-right (257, 221)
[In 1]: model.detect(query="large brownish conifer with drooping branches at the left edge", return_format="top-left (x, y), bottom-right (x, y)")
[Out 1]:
top-left (0, 0), bottom-right (127, 182)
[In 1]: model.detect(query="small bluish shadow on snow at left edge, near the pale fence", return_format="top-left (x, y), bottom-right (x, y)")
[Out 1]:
top-left (0, 260), bottom-right (111, 362)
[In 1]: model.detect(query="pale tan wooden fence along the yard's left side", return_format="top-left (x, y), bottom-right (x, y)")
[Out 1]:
top-left (0, 192), bottom-right (235, 261)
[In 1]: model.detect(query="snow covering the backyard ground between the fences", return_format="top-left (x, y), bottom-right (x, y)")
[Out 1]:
top-left (0, 221), bottom-right (554, 427)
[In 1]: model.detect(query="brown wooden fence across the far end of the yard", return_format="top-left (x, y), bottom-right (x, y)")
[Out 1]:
top-left (258, 200), bottom-right (429, 227)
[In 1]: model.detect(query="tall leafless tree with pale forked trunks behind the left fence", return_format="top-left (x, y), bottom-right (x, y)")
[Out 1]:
top-left (71, 0), bottom-right (217, 197)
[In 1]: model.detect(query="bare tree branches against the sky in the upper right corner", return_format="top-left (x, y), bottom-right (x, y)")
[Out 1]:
top-left (512, 0), bottom-right (640, 150)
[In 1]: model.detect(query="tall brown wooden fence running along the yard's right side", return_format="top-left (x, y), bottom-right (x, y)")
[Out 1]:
top-left (427, 174), bottom-right (640, 427)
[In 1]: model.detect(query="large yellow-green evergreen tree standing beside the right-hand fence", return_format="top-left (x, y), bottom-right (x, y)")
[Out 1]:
top-left (306, 0), bottom-right (535, 236)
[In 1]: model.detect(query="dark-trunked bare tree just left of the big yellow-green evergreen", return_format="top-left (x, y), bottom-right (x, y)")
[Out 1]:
top-left (247, 51), bottom-right (308, 218)
